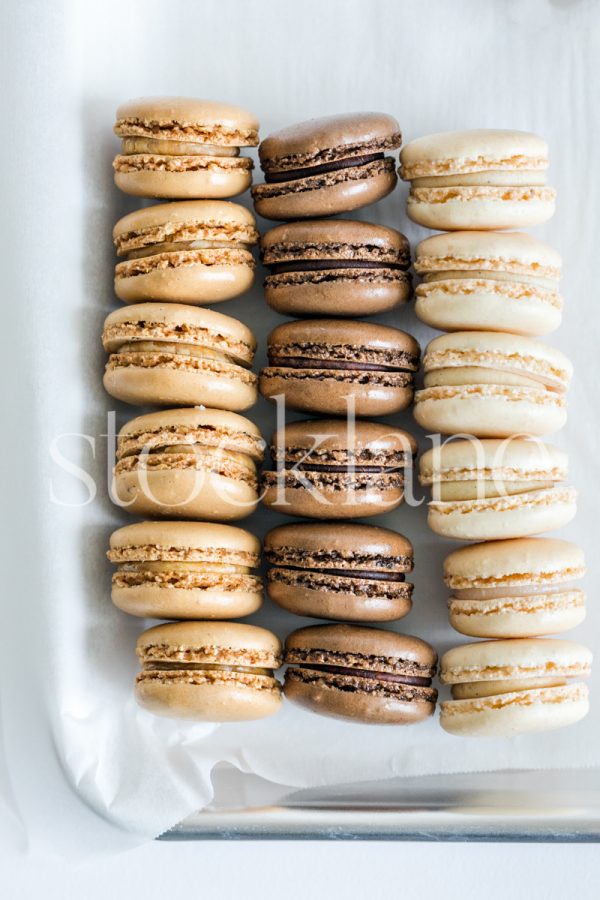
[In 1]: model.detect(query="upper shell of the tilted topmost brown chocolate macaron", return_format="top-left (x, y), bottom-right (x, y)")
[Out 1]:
top-left (258, 112), bottom-right (402, 174)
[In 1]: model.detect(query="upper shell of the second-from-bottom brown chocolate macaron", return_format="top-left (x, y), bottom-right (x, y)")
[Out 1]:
top-left (264, 522), bottom-right (413, 572)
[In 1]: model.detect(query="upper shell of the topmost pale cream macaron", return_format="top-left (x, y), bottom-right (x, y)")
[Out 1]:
top-left (400, 128), bottom-right (548, 181)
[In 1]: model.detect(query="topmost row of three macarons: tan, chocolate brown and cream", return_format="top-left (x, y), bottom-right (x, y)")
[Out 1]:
top-left (113, 97), bottom-right (555, 231)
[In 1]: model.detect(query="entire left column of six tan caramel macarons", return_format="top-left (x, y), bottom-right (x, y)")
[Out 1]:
top-left (102, 97), bottom-right (282, 721)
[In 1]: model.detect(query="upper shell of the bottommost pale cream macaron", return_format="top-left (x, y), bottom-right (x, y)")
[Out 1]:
top-left (440, 638), bottom-right (592, 684)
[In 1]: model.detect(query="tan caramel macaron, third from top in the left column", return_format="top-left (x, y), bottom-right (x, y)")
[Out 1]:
top-left (102, 303), bottom-right (258, 410)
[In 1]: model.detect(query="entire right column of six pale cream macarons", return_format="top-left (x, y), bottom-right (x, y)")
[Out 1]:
top-left (400, 130), bottom-right (591, 735)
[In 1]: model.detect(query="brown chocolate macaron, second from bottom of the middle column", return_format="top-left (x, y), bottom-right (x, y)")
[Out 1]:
top-left (264, 522), bottom-right (413, 622)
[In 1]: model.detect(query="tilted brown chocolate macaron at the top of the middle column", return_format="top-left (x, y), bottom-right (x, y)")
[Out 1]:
top-left (252, 112), bottom-right (402, 219)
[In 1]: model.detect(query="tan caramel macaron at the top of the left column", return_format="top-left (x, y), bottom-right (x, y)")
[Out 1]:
top-left (113, 97), bottom-right (258, 199)
